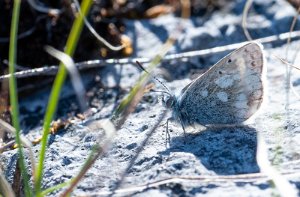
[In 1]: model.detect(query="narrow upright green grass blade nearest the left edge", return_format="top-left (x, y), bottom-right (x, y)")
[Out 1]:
top-left (9, 0), bottom-right (31, 196)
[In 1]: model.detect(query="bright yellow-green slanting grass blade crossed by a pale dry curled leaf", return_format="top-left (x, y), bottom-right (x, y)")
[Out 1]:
top-left (35, 0), bottom-right (93, 196)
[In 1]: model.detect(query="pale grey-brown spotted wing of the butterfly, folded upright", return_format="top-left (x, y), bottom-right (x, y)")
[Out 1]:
top-left (177, 43), bottom-right (264, 125)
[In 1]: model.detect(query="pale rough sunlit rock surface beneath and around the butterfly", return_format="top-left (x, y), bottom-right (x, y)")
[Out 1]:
top-left (0, 0), bottom-right (300, 196)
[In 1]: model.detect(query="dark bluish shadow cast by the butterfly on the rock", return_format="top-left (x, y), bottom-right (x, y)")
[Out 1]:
top-left (164, 126), bottom-right (259, 175)
